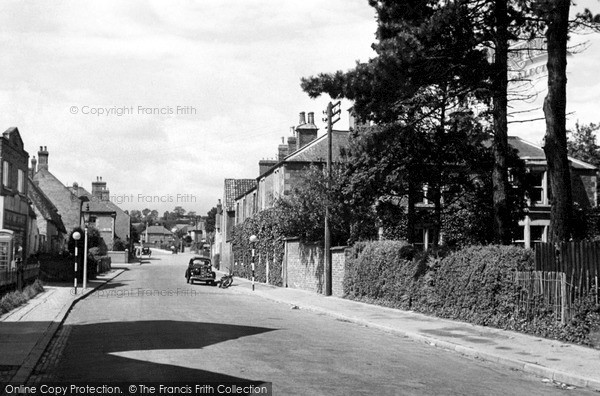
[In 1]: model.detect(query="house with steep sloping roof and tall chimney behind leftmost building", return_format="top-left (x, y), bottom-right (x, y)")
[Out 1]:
top-left (31, 146), bottom-right (86, 238)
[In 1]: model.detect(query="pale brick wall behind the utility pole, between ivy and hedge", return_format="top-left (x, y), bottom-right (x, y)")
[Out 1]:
top-left (283, 239), bottom-right (346, 296)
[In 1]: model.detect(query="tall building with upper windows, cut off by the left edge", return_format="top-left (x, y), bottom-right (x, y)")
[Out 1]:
top-left (0, 127), bottom-right (32, 271)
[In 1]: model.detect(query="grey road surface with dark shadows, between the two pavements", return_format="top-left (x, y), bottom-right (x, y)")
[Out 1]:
top-left (31, 254), bottom-right (595, 395)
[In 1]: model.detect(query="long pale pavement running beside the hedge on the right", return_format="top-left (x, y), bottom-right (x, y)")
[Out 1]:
top-left (221, 272), bottom-right (600, 391)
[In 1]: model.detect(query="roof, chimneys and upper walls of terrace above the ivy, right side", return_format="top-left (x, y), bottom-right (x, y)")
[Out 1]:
top-left (235, 112), bottom-right (349, 224)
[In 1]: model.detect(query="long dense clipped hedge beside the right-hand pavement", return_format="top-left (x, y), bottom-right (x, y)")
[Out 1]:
top-left (344, 241), bottom-right (600, 347)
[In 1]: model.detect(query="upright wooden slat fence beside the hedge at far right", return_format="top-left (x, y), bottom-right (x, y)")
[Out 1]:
top-left (515, 241), bottom-right (600, 324)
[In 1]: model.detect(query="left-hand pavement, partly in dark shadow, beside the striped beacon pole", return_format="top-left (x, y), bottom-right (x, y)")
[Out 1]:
top-left (0, 269), bottom-right (125, 384)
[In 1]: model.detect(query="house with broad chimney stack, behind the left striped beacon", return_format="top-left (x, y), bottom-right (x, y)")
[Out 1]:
top-left (69, 176), bottom-right (131, 250)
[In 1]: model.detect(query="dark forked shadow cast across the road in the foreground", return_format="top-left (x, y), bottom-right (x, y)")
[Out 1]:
top-left (40, 320), bottom-right (276, 384)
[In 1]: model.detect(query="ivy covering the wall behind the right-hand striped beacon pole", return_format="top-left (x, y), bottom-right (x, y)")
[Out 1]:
top-left (232, 209), bottom-right (285, 286)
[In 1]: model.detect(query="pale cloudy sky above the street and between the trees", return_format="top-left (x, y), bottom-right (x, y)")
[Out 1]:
top-left (0, 0), bottom-right (600, 214)
